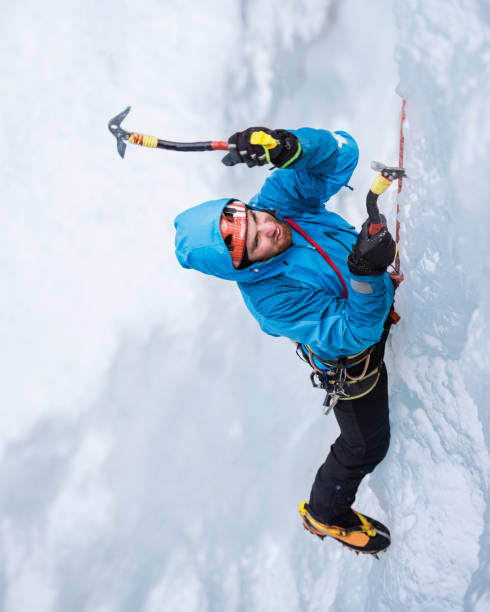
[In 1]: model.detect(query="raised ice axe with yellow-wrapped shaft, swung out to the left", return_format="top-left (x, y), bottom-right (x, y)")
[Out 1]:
top-left (108, 106), bottom-right (228, 157)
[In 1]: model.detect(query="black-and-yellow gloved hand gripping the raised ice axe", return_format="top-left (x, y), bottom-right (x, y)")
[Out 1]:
top-left (221, 127), bottom-right (301, 168)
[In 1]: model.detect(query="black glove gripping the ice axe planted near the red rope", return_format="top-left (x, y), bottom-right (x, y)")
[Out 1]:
top-left (347, 215), bottom-right (396, 276)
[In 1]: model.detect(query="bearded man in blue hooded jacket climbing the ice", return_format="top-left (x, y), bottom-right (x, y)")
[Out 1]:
top-left (175, 127), bottom-right (395, 554)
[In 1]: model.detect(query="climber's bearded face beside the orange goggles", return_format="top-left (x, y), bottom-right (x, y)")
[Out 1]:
top-left (246, 209), bottom-right (292, 261)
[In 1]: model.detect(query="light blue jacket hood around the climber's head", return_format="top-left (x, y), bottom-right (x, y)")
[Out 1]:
top-left (175, 198), bottom-right (284, 282)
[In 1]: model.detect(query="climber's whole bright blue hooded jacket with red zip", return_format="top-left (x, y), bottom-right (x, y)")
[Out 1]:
top-left (175, 128), bottom-right (393, 360)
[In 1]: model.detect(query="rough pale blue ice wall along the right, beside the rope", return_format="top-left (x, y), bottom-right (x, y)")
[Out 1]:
top-left (385, 1), bottom-right (490, 610)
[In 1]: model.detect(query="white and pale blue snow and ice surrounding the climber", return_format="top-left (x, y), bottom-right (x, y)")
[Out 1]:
top-left (0, 0), bottom-right (490, 612)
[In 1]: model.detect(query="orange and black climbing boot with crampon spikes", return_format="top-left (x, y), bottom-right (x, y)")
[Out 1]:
top-left (299, 502), bottom-right (391, 556)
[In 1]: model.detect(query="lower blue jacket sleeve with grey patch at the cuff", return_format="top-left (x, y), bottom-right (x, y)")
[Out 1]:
top-left (240, 274), bottom-right (393, 359)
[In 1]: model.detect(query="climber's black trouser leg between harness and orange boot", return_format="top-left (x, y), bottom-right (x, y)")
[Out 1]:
top-left (309, 363), bottom-right (390, 523)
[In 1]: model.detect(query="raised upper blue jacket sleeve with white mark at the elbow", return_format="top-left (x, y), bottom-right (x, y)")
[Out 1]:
top-left (250, 128), bottom-right (359, 215)
